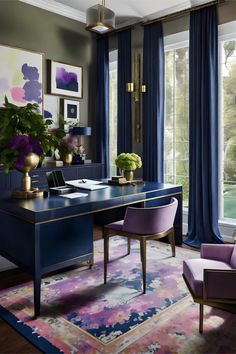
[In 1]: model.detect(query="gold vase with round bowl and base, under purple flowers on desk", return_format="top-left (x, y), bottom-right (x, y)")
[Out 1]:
top-left (12, 152), bottom-right (43, 199)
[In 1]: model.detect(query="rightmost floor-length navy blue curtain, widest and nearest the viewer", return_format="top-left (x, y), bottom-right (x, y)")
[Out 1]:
top-left (185, 6), bottom-right (223, 247)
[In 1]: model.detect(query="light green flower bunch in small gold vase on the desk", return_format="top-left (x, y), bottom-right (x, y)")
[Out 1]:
top-left (115, 152), bottom-right (142, 181)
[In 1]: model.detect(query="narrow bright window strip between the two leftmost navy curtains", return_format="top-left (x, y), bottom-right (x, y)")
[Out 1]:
top-left (109, 50), bottom-right (117, 176)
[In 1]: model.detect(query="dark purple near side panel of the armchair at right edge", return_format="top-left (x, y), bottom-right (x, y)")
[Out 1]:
top-left (203, 269), bottom-right (236, 303)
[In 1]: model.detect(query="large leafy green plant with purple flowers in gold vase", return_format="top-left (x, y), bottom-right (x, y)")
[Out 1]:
top-left (0, 97), bottom-right (65, 195)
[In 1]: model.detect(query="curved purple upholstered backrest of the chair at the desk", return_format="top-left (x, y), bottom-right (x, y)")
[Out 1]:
top-left (123, 198), bottom-right (178, 235)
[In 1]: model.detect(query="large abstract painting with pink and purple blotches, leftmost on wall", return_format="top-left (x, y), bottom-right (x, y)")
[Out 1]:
top-left (0, 45), bottom-right (43, 112)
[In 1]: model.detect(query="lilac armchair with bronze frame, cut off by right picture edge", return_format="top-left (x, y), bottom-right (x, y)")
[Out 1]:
top-left (183, 244), bottom-right (236, 333)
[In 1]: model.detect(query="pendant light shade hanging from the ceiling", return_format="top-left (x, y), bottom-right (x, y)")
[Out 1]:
top-left (86, 0), bottom-right (115, 34)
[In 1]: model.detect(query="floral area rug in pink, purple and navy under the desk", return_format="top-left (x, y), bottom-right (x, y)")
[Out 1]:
top-left (0, 237), bottom-right (236, 354)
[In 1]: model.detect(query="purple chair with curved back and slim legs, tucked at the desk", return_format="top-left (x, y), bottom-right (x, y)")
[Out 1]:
top-left (103, 198), bottom-right (178, 293)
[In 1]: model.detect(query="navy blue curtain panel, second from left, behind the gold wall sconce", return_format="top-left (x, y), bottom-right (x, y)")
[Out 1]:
top-left (117, 29), bottom-right (132, 154)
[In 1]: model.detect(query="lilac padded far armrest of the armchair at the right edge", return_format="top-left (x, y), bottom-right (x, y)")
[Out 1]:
top-left (201, 243), bottom-right (234, 263)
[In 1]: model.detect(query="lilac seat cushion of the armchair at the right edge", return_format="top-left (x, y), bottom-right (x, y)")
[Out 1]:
top-left (183, 258), bottom-right (232, 297)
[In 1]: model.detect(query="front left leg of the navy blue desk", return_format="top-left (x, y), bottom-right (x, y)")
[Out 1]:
top-left (34, 225), bottom-right (41, 318)
